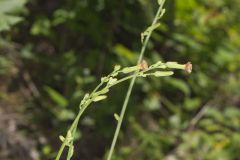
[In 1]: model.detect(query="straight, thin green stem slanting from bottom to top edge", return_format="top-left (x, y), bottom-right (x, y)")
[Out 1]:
top-left (107, 1), bottom-right (164, 160)
